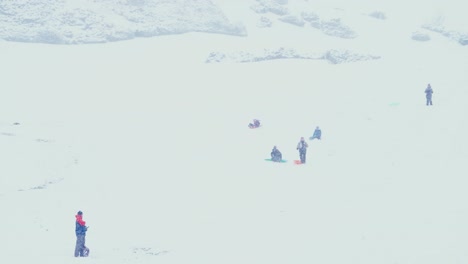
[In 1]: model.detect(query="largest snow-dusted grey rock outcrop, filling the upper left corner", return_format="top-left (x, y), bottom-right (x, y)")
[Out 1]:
top-left (0, 0), bottom-right (246, 44)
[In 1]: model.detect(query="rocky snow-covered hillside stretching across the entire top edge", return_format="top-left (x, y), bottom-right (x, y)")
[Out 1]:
top-left (0, 0), bottom-right (468, 64)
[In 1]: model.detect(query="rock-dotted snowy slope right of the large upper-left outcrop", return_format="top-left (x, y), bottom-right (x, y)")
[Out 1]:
top-left (206, 0), bottom-right (468, 63)
